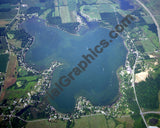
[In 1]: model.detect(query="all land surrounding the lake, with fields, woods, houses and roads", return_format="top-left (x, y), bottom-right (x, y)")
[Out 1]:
top-left (0, 0), bottom-right (160, 128)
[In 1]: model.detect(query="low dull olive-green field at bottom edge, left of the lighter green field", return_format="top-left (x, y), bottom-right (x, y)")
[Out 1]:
top-left (26, 120), bottom-right (66, 128)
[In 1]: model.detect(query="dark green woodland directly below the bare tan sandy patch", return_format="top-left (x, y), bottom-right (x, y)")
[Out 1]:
top-left (136, 67), bottom-right (160, 109)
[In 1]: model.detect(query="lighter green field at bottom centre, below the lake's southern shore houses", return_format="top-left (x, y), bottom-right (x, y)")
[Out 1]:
top-left (74, 115), bottom-right (107, 128)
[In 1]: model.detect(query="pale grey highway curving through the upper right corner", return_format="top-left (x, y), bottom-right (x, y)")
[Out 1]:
top-left (136, 0), bottom-right (160, 43)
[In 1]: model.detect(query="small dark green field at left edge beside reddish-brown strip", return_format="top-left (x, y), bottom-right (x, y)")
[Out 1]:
top-left (0, 54), bottom-right (9, 73)
